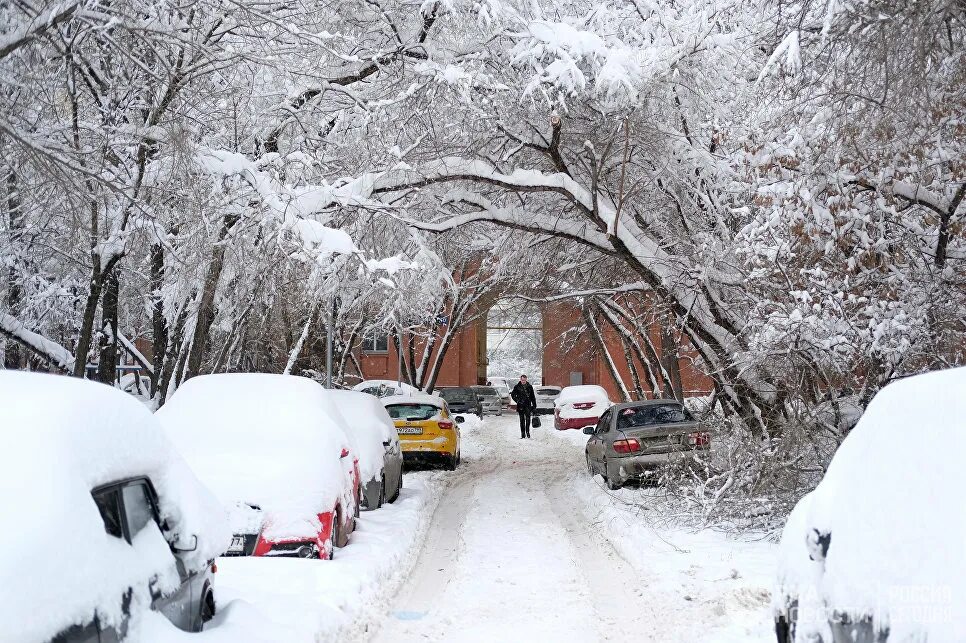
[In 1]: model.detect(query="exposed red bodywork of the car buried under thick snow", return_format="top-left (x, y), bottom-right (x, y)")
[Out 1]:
top-left (252, 450), bottom-right (362, 560)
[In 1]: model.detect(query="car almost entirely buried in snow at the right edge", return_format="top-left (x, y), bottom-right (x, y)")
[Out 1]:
top-left (773, 368), bottom-right (966, 643)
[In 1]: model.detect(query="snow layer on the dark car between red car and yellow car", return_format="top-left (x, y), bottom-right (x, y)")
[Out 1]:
top-left (326, 391), bottom-right (396, 484)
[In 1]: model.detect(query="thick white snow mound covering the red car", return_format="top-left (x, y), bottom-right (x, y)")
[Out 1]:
top-left (156, 373), bottom-right (351, 539)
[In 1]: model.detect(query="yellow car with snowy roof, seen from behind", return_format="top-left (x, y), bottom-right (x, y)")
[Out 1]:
top-left (382, 393), bottom-right (463, 471)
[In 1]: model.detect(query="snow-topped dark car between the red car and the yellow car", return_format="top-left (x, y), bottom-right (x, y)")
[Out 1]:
top-left (326, 391), bottom-right (403, 509)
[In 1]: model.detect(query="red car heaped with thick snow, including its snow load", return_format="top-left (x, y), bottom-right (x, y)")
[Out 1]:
top-left (156, 373), bottom-right (361, 558)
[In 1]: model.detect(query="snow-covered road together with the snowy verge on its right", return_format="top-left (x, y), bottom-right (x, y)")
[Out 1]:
top-left (360, 415), bottom-right (776, 643)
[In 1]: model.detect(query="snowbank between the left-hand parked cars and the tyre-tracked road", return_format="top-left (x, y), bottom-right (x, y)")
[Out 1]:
top-left (208, 472), bottom-right (444, 643)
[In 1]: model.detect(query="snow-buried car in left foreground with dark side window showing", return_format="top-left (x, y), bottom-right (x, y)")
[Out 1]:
top-left (0, 371), bottom-right (231, 643)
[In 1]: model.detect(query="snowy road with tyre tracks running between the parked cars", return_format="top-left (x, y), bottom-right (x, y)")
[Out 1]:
top-left (366, 416), bottom-right (776, 643)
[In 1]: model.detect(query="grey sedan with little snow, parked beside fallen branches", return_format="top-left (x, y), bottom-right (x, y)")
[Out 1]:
top-left (584, 400), bottom-right (711, 489)
